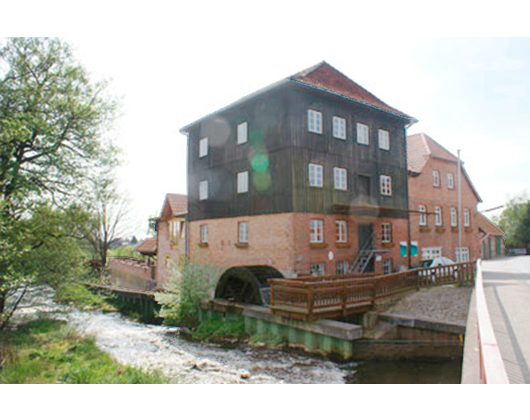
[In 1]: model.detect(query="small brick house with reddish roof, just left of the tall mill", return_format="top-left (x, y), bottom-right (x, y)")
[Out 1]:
top-left (153, 194), bottom-right (188, 287)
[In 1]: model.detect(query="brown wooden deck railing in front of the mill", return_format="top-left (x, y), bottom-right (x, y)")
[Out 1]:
top-left (269, 263), bottom-right (475, 320)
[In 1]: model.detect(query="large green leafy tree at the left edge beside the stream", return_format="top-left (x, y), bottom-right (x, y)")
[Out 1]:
top-left (0, 37), bottom-right (115, 338)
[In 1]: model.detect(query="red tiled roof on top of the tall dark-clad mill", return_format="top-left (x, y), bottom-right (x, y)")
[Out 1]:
top-left (290, 61), bottom-right (413, 120)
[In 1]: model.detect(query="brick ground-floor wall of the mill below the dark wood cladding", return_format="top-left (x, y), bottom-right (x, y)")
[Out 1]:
top-left (190, 213), bottom-right (408, 277)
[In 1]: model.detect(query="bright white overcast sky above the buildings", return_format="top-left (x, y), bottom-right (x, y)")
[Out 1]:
top-left (63, 37), bottom-right (530, 238)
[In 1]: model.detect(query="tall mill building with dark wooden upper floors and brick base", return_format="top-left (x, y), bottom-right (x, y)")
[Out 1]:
top-left (179, 62), bottom-right (415, 296)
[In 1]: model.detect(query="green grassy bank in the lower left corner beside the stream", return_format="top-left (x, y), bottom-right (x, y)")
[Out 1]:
top-left (0, 319), bottom-right (167, 384)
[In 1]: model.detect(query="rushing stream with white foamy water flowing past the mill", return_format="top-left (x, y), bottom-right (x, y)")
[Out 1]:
top-left (10, 287), bottom-right (460, 384)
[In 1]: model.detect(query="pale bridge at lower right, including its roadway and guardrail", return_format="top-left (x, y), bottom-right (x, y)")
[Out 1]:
top-left (462, 256), bottom-right (530, 384)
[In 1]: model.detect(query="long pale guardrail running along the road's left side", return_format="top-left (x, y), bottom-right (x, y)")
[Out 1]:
top-left (475, 260), bottom-right (510, 385)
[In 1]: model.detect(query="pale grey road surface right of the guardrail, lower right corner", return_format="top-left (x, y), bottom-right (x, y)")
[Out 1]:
top-left (482, 256), bottom-right (530, 384)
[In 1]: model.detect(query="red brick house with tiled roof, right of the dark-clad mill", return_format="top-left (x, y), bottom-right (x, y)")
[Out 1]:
top-left (407, 133), bottom-right (482, 264)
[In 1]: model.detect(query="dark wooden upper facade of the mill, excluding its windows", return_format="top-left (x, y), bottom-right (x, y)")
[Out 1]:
top-left (182, 72), bottom-right (410, 225)
